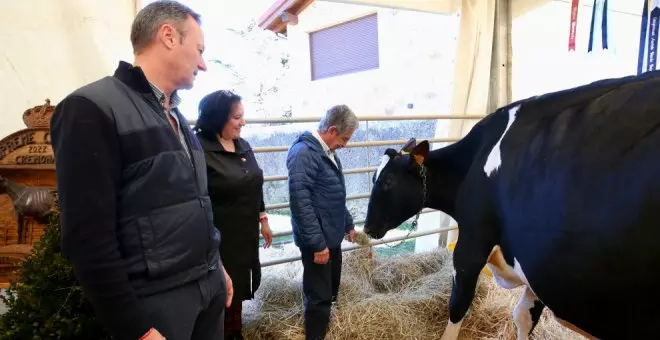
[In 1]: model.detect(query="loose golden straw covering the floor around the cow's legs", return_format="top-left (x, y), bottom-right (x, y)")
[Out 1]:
top-left (244, 248), bottom-right (583, 340)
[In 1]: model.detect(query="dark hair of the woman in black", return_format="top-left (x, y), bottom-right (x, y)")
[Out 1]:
top-left (194, 90), bottom-right (241, 141)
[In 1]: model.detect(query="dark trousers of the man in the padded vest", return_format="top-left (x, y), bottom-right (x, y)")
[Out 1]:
top-left (141, 268), bottom-right (227, 340)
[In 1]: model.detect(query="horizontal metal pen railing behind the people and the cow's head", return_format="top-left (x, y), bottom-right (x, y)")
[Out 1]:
top-left (189, 114), bottom-right (485, 267)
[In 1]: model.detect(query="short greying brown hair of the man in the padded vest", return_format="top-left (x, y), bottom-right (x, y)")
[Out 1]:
top-left (131, 0), bottom-right (201, 54)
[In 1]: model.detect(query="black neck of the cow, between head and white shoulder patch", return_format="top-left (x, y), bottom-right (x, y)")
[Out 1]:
top-left (425, 126), bottom-right (481, 218)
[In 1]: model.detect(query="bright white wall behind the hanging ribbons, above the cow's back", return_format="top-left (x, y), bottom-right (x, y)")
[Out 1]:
top-left (512, 0), bottom-right (643, 100)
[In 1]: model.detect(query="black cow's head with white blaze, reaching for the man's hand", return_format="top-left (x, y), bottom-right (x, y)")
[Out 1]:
top-left (364, 138), bottom-right (429, 239)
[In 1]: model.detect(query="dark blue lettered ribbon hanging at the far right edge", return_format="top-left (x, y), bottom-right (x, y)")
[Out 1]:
top-left (637, 0), bottom-right (660, 74)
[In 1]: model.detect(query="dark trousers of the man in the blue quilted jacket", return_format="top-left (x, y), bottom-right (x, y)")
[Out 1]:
top-left (300, 247), bottom-right (342, 340)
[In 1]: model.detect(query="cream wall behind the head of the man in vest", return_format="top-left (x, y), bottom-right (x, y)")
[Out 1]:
top-left (0, 0), bottom-right (134, 138)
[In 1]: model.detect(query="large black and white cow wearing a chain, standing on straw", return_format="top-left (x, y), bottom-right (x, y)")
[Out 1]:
top-left (365, 72), bottom-right (660, 340)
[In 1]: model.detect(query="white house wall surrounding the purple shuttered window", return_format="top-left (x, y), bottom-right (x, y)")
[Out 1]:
top-left (288, 1), bottom-right (458, 116)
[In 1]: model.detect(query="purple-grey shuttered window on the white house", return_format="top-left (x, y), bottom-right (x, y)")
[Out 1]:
top-left (309, 14), bottom-right (379, 80)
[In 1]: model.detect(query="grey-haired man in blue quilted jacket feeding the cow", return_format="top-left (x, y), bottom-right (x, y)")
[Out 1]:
top-left (286, 105), bottom-right (358, 340)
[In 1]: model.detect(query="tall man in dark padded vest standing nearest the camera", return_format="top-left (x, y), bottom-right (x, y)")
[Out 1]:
top-left (51, 1), bottom-right (232, 340)
